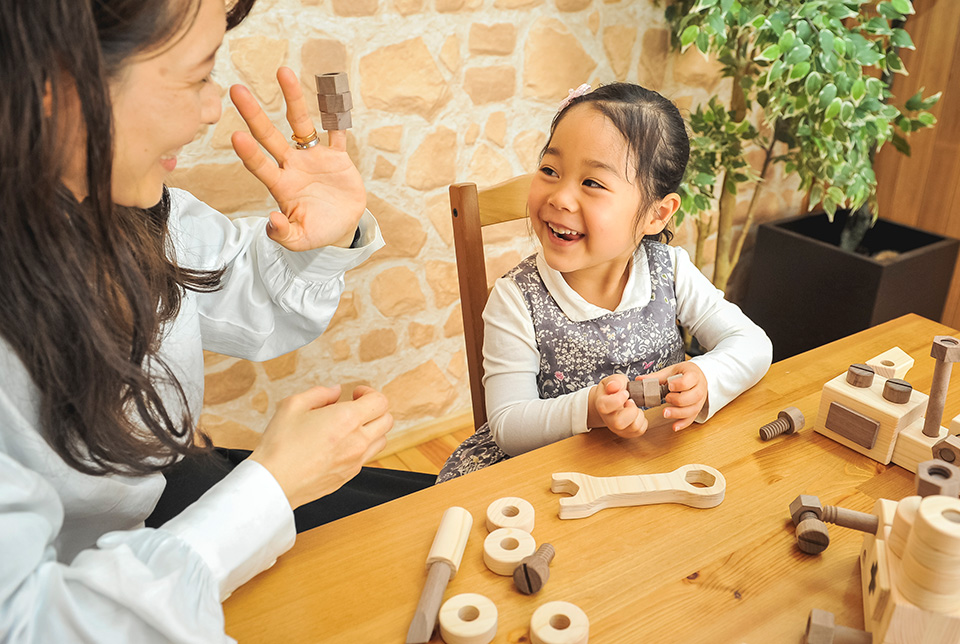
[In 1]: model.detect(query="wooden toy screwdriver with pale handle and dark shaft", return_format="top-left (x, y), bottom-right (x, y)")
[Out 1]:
top-left (406, 506), bottom-right (473, 644)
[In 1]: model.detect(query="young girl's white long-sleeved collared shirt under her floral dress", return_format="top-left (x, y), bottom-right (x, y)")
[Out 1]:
top-left (483, 246), bottom-right (773, 456)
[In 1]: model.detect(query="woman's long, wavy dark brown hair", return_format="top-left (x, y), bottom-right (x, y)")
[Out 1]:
top-left (0, 0), bottom-right (253, 475)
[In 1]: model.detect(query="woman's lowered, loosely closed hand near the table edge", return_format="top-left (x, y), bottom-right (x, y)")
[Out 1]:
top-left (250, 386), bottom-right (393, 508)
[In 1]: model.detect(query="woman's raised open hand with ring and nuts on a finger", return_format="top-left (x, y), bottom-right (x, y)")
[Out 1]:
top-left (230, 67), bottom-right (367, 251)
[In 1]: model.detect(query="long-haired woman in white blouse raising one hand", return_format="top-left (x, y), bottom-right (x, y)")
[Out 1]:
top-left (0, 0), bottom-right (430, 642)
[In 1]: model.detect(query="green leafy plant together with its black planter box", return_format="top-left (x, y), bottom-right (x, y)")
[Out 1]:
top-left (666, 0), bottom-right (956, 359)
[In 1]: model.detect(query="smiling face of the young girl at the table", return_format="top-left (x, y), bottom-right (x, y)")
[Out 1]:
top-left (527, 104), bottom-right (664, 300)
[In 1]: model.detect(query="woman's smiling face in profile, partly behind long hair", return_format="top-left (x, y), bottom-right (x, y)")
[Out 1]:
top-left (110, 0), bottom-right (226, 208)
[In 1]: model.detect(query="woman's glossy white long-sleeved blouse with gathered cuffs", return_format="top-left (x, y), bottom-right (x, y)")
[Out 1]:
top-left (0, 190), bottom-right (383, 644)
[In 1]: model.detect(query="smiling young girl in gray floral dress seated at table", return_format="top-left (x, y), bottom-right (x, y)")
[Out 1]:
top-left (438, 83), bottom-right (772, 481)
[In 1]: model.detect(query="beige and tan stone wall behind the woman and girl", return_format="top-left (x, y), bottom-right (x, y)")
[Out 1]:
top-left (171, 0), bottom-right (799, 448)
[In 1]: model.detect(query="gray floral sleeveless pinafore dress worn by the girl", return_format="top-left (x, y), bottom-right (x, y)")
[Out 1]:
top-left (437, 240), bottom-right (683, 483)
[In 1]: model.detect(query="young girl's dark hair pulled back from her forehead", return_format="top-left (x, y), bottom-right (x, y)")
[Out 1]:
top-left (541, 83), bottom-right (690, 243)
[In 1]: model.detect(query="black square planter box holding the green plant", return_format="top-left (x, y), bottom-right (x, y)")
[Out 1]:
top-left (743, 211), bottom-right (960, 360)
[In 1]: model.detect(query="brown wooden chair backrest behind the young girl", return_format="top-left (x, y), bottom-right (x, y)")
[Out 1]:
top-left (450, 174), bottom-right (533, 427)
